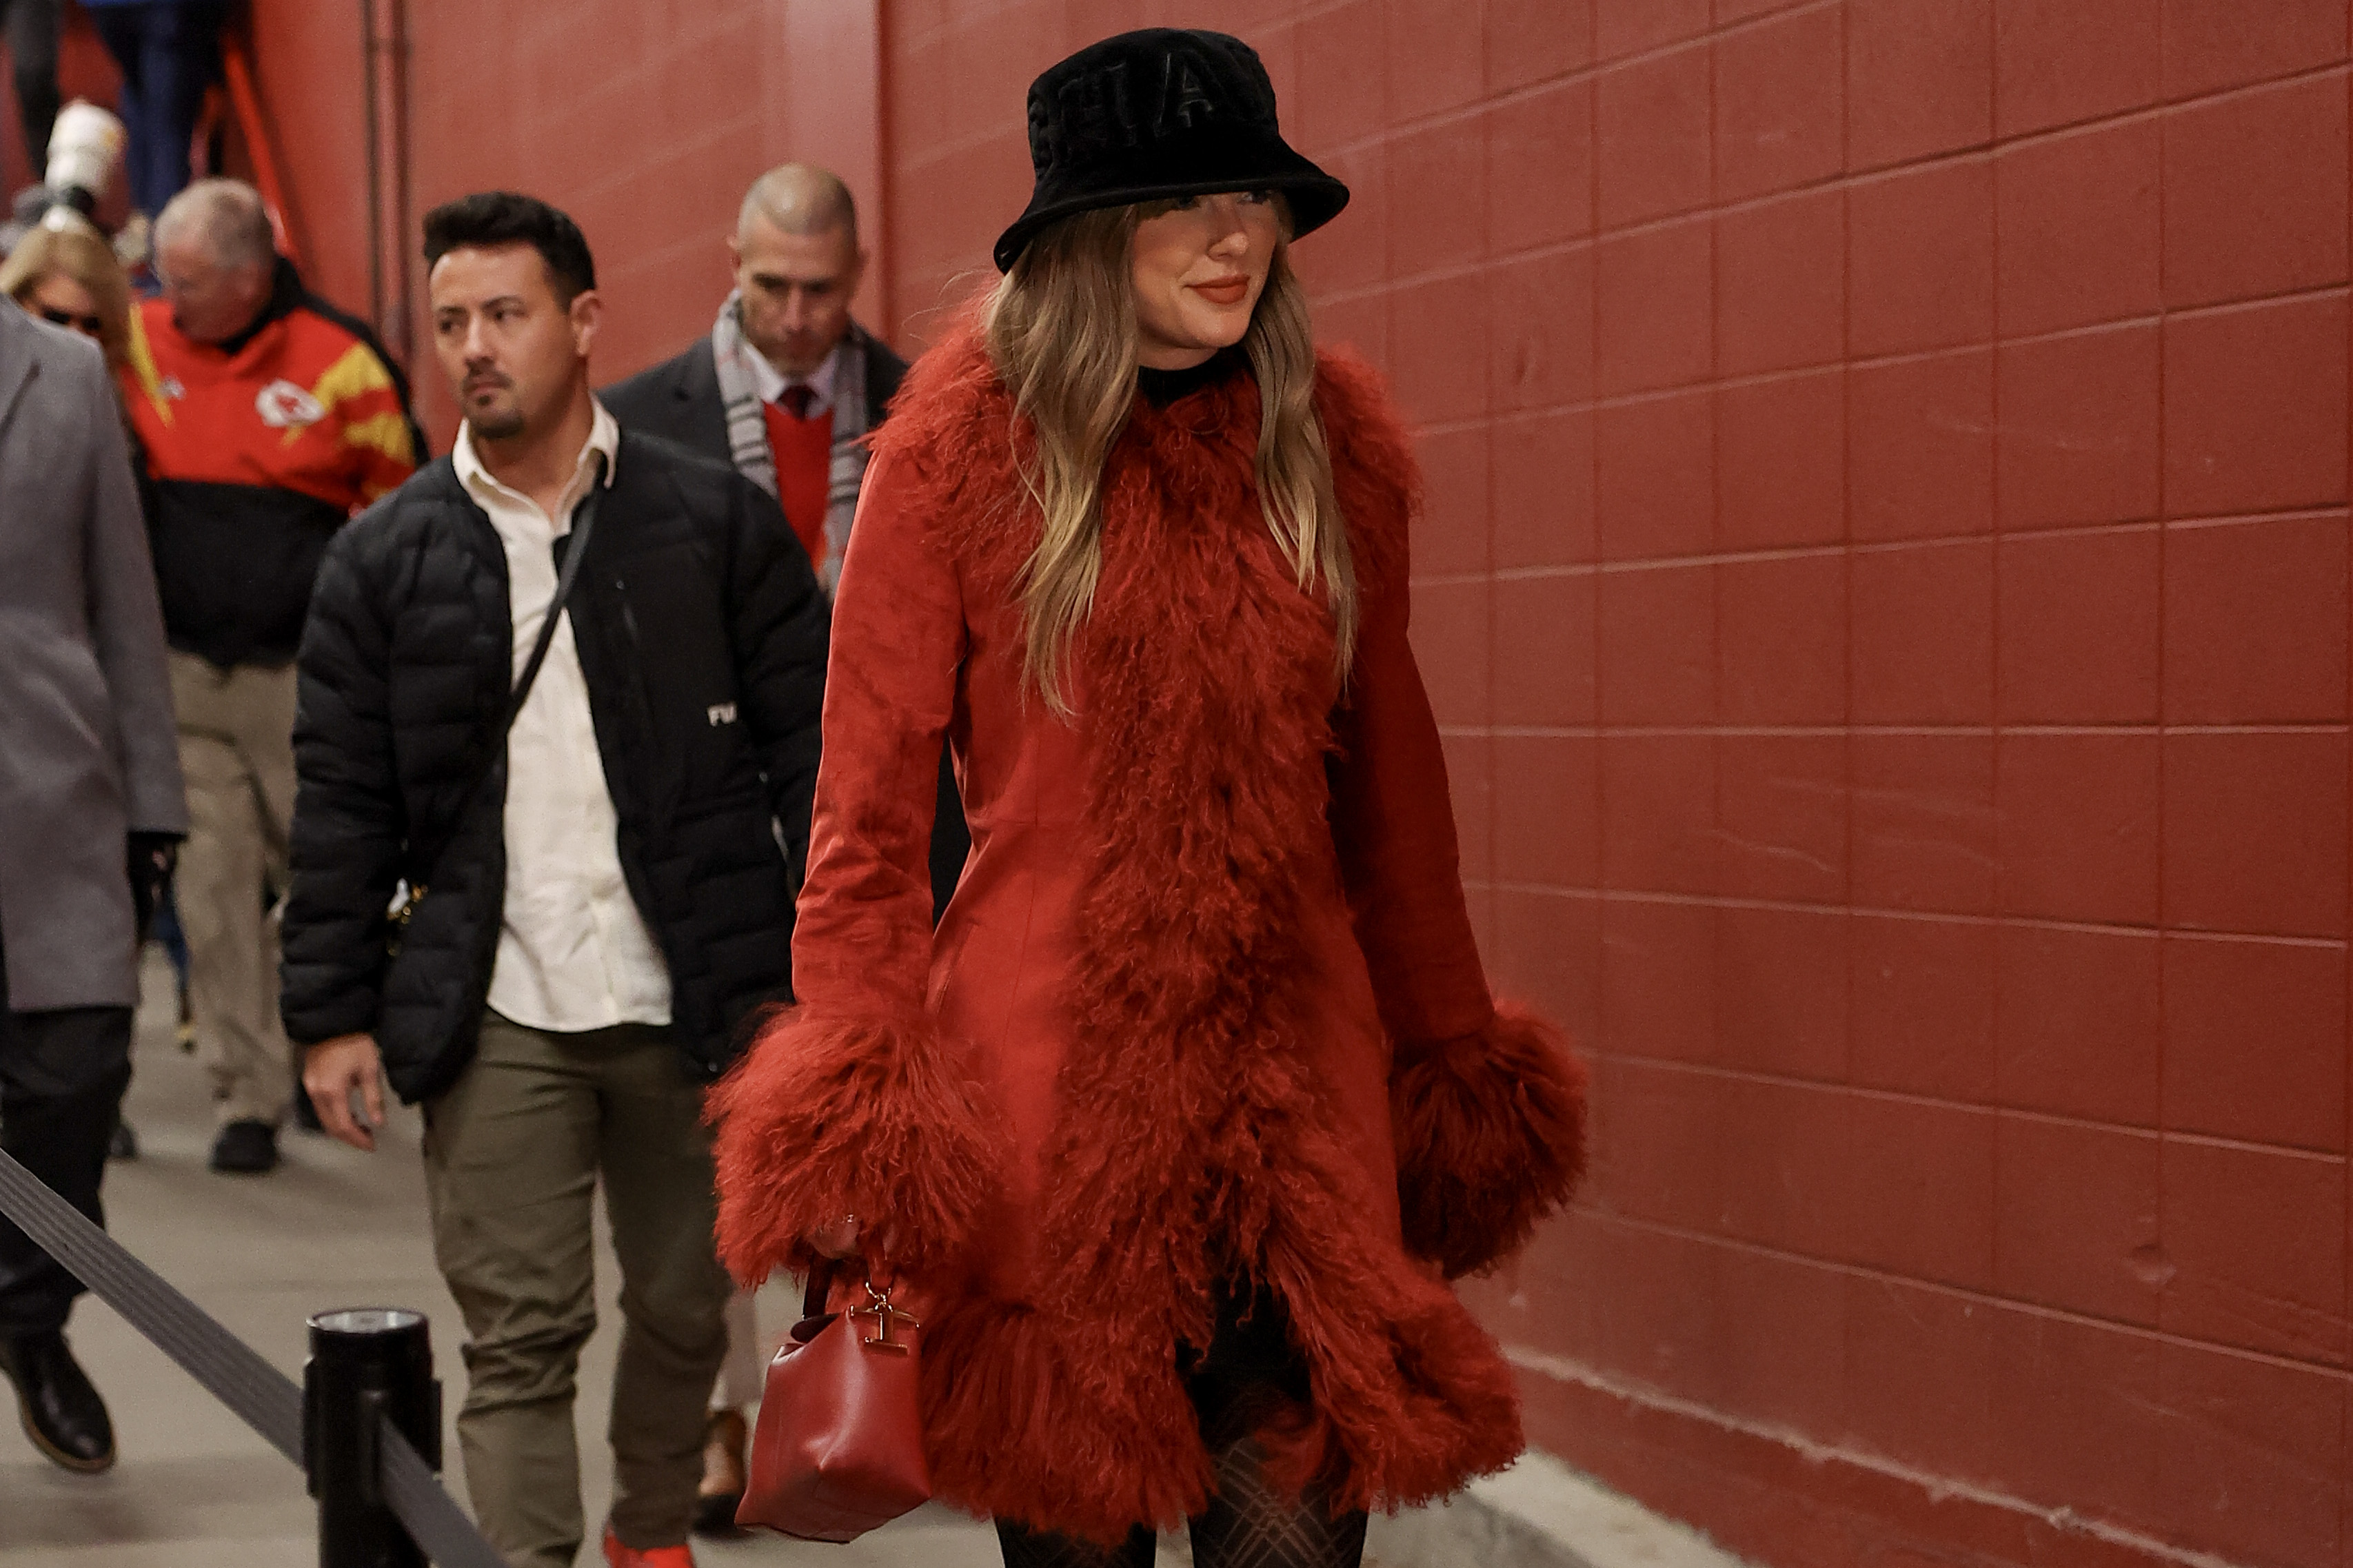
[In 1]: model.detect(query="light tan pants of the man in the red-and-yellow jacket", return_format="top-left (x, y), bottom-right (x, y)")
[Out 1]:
top-left (172, 649), bottom-right (294, 1126)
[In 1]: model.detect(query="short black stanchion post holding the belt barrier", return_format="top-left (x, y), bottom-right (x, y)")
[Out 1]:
top-left (301, 1307), bottom-right (440, 1568)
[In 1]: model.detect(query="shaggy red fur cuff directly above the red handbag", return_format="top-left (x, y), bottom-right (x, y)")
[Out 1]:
top-left (706, 1008), bottom-right (1000, 1286)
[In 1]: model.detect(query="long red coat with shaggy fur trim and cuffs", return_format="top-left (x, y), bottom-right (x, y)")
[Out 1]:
top-left (713, 329), bottom-right (1584, 1540)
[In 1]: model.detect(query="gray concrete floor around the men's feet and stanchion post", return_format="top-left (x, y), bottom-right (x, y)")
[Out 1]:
top-left (0, 959), bottom-right (998, 1568)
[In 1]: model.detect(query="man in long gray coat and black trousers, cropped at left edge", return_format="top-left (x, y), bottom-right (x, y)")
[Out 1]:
top-left (0, 301), bottom-right (188, 1472)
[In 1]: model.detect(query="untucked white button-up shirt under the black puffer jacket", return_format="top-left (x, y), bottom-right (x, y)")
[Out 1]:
top-left (450, 405), bottom-right (671, 1035)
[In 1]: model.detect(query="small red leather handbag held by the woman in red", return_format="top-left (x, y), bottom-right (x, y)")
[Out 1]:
top-left (736, 1263), bottom-right (932, 1542)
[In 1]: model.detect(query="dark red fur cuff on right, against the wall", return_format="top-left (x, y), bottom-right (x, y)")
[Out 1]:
top-left (1388, 1008), bottom-right (1586, 1279)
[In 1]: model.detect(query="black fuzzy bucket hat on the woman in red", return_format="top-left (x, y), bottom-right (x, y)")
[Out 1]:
top-left (996, 28), bottom-right (1349, 273)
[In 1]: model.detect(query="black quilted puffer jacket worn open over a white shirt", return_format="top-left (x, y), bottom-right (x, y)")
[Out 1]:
top-left (283, 430), bottom-right (826, 1100)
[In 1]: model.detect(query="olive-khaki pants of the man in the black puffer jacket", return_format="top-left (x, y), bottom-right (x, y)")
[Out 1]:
top-left (426, 1013), bottom-right (731, 1568)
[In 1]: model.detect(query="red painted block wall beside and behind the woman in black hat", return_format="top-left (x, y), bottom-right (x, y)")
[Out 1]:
top-left (243, 0), bottom-right (2353, 1568)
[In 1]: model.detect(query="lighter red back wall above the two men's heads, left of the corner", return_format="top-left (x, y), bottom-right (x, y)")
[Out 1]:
top-left (254, 0), bottom-right (882, 451)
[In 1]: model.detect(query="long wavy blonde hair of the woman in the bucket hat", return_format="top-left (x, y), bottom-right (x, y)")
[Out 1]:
top-left (984, 202), bottom-right (1357, 717)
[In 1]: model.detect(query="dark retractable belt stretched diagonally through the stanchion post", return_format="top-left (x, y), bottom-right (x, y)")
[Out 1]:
top-left (0, 1150), bottom-right (506, 1568)
